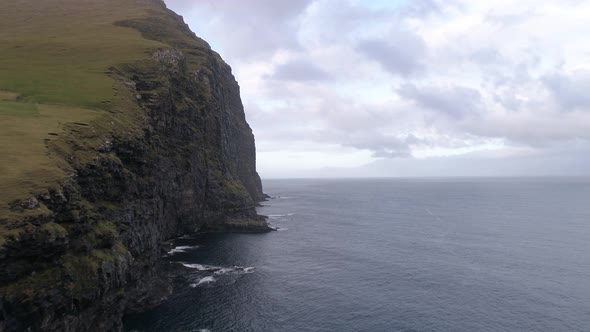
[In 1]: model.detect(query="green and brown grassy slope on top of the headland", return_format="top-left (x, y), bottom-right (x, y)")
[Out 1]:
top-left (0, 0), bottom-right (171, 219)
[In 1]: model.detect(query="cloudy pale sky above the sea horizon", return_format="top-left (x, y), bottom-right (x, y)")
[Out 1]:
top-left (165, 0), bottom-right (590, 178)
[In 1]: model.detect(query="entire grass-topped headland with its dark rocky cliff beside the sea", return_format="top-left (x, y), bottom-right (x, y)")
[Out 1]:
top-left (0, 0), bottom-right (270, 331)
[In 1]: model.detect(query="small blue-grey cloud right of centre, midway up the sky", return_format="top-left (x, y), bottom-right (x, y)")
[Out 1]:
top-left (397, 83), bottom-right (481, 119)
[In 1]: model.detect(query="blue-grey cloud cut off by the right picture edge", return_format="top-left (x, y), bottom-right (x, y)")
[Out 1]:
top-left (543, 71), bottom-right (590, 111)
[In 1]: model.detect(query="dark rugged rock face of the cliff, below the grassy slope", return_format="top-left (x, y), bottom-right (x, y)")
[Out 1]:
top-left (0, 0), bottom-right (269, 331)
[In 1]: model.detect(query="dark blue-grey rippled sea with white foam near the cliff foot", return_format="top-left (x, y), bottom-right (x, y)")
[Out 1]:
top-left (126, 178), bottom-right (590, 332)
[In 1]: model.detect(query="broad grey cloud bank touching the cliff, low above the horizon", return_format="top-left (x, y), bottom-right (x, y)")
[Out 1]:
top-left (247, 91), bottom-right (421, 158)
